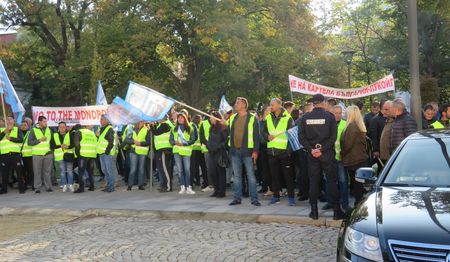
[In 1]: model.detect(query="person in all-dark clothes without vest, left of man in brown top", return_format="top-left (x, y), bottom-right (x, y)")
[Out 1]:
top-left (206, 111), bottom-right (231, 198)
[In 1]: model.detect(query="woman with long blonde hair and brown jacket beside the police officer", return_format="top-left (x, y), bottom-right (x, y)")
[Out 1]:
top-left (341, 105), bottom-right (369, 206)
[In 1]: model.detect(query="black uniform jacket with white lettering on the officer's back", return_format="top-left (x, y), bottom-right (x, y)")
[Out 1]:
top-left (300, 108), bottom-right (337, 152)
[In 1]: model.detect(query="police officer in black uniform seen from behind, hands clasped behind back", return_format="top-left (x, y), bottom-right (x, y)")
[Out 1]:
top-left (300, 94), bottom-right (344, 220)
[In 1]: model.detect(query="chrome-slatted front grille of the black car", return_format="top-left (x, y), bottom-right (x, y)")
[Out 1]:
top-left (388, 240), bottom-right (450, 262)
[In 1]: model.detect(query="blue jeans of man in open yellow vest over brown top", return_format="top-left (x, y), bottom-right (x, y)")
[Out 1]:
top-left (231, 149), bottom-right (258, 201)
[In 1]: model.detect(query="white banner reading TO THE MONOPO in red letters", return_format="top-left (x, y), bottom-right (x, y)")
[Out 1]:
top-left (32, 105), bottom-right (108, 126)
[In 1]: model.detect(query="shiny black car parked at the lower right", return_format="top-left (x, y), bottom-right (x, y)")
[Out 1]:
top-left (337, 129), bottom-right (450, 262)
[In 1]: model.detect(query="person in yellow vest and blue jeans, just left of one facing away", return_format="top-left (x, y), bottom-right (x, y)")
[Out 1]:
top-left (50, 122), bottom-right (75, 192)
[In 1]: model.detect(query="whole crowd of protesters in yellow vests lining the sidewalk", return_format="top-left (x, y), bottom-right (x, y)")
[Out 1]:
top-left (0, 94), bottom-right (450, 219)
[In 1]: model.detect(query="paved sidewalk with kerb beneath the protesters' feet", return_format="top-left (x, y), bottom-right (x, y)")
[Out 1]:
top-left (0, 184), bottom-right (340, 226)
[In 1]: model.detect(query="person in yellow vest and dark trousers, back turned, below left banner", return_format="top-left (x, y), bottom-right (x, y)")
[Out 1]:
top-left (72, 125), bottom-right (97, 193)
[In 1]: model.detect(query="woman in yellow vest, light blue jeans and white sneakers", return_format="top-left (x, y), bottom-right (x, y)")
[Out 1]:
top-left (169, 113), bottom-right (195, 194)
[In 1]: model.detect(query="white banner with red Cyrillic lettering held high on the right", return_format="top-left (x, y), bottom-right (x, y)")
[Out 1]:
top-left (289, 74), bottom-right (395, 99)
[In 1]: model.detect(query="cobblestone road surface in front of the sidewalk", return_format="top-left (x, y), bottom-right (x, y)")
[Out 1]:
top-left (0, 217), bottom-right (338, 261)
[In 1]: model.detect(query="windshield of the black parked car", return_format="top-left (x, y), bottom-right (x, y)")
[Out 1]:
top-left (383, 137), bottom-right (450, 187)
